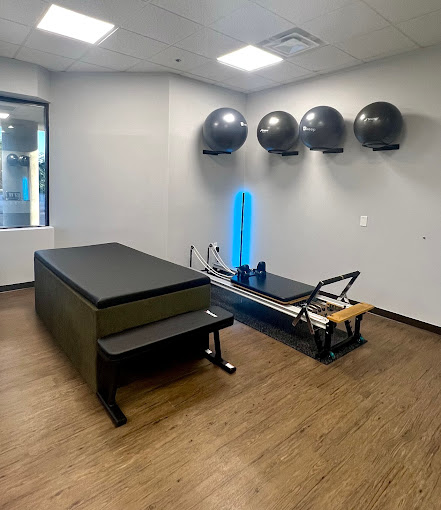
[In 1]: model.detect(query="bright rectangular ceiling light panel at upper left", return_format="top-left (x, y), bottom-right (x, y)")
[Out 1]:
top-left (37, 4), bottom-right (115, 44)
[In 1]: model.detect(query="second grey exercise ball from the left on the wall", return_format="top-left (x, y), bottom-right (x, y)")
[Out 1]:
top-left (257, 111), bottom-right (299, 152)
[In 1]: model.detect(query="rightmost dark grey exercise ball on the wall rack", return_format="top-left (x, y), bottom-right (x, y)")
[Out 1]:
top-left (354, 101), bottom-right (403, 148)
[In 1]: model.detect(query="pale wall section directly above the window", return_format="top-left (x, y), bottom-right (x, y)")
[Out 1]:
top-left (0, 57), bottom-right (51, 101)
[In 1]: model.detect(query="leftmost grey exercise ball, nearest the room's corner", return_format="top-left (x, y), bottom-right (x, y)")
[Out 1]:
top-left (202, 108), bottom-right (248, 152)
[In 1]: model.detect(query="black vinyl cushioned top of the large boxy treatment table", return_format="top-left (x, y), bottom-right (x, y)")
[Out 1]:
top-left (35, 243), bottom-right (210, 308)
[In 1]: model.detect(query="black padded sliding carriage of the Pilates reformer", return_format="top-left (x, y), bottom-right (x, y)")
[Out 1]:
top-left (231, 273), bottom-right (314, 304)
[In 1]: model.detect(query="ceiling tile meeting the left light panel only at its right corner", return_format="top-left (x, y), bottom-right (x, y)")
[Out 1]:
top-left (122, 4), bottom-right (201, 44)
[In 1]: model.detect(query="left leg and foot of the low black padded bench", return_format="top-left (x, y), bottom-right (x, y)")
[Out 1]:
top-left (97, 353), bottom-right (127, 427)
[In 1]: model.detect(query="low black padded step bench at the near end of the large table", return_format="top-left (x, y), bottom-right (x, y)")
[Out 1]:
top-left (97, 306), bottom-right (236, 427)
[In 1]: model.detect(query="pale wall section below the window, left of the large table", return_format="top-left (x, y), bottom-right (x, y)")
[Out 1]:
top-left (0, 227), bottom-right (54, 287)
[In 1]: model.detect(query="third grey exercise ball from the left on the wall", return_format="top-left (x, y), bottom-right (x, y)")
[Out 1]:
top-left (300, 106), bottom-right (345, 150)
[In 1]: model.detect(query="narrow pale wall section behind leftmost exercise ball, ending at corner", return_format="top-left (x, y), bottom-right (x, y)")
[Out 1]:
top-left (168, 76), bottom-right (246, 265)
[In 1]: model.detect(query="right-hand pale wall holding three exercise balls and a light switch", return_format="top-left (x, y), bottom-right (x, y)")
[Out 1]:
top-left (246, 48), bottom-right (441, 325)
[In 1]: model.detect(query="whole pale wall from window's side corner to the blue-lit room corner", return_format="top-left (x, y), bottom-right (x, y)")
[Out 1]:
top-left (50, 73), bottom-right (246, 264)
